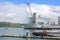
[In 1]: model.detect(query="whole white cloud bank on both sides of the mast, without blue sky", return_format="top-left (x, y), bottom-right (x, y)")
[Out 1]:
top-left (0, 2), bottom-right (60, 23)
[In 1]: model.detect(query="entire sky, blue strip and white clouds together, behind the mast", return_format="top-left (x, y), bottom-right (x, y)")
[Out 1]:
top-left (0, 0), bottom-right (60, 23)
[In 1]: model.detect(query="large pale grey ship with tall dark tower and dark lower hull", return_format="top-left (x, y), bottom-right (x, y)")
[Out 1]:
top-left (25, 2), bottom-right (60, 36)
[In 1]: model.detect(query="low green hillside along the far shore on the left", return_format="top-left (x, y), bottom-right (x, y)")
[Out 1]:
top-left (0, 22), bottom-right (25, 28)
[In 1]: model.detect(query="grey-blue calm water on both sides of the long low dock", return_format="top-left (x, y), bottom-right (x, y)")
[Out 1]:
top-left (0, 28), bottom-right (53, 40)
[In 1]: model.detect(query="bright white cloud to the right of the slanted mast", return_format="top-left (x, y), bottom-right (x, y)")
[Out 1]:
top-left (28, 4), bottom-right (60, 22)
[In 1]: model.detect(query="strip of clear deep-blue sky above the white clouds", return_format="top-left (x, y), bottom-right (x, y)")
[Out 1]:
top-left (0, 0), bottom-right (60, 6)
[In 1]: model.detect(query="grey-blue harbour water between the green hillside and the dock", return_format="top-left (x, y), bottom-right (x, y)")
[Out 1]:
top-left (0, 27), bottom-right (26, 35)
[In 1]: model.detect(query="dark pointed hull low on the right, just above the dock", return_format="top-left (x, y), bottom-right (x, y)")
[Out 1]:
top-left (32, 31), bottom-right (60, 37)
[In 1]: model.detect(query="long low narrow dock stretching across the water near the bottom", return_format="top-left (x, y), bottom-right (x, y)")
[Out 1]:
top-left (0, 35), bottom-right (60, 39)
